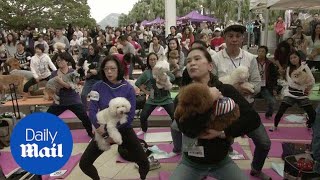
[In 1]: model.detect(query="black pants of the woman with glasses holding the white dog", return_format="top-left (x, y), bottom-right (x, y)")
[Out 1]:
top-left (79, 128), bottom-right (149, 180)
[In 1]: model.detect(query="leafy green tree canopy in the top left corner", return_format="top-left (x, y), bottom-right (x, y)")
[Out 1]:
top-left (0, 0), bottom-right (96, 29)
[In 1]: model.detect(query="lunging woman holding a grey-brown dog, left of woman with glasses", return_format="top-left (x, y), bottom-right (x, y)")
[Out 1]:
top-left (47, 52), bottom-right (93, 137)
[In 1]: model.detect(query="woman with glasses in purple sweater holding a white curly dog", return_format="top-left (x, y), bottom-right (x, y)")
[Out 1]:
top-left (79, 56), bottom-right (149, 180)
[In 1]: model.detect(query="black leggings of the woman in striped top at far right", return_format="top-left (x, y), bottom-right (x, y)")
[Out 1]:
top-left (274, 102), bottom-right (316, 127)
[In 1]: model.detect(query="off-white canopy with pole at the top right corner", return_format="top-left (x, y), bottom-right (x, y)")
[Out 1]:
top-left (250, 0), bottom-right (320, 46)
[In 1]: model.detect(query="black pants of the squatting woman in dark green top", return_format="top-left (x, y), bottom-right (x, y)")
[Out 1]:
top-left (140, 103), bottom-right (174, 132)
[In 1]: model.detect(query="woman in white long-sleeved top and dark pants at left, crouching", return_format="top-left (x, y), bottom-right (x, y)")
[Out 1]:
top-left (23, 44), bottom-right (57, 100)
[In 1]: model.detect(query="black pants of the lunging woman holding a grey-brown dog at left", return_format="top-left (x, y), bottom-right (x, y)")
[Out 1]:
top-left (47, 103), bottom-right (93, 137)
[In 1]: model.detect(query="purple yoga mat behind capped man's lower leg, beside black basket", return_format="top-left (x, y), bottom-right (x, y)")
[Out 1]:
top-left (249, 139), bottom-right (310, 158)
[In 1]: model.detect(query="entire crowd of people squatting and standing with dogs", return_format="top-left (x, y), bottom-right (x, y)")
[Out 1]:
top-left (0, 10), bottom-right (320, 180)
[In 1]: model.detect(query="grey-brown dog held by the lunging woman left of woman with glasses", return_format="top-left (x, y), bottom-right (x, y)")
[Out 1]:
top-left (43, 72), bottom-right (80, 104)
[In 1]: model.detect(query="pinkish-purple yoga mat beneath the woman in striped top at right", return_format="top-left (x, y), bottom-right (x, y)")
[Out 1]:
top-left (266, 127), bottom-right (312, 141)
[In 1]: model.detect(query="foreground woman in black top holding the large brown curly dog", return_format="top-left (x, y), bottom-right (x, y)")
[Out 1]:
top-left (170, 47), bottom-right (260, 180)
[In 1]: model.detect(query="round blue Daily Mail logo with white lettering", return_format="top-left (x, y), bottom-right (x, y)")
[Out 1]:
top-left (10, 113), bottom-right (73, 175)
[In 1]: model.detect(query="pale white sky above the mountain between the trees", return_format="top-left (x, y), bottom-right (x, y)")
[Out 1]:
top-left (88, 0), bottom-right (139, 22)
